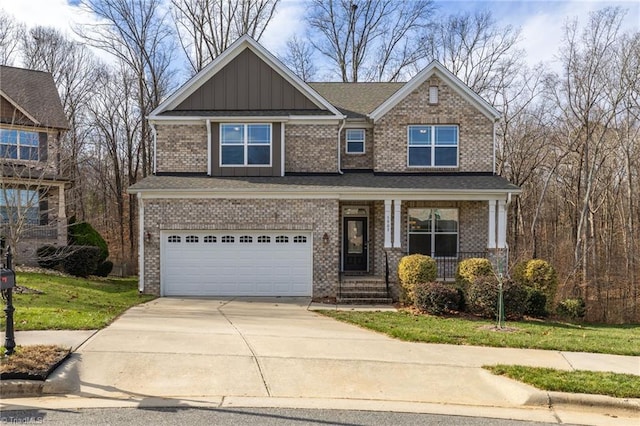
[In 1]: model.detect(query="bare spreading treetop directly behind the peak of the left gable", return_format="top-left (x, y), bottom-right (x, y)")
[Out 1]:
top-left (171, 0), bottom-right (280, 74)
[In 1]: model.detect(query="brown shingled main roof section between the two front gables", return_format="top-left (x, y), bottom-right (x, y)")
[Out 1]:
top-left (309, 82), bottom-right (405, 118)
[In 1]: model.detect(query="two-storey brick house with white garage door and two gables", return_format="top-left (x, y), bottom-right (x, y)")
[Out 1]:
top-left (129, 36), bottom-right (520, 301)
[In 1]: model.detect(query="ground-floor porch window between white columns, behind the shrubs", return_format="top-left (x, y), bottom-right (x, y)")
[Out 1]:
top-left (409, 208), bottom-right (458, 257)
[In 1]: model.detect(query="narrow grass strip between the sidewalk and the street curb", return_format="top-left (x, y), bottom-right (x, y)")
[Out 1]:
top-left (483, 365), bottom-right (640, 398)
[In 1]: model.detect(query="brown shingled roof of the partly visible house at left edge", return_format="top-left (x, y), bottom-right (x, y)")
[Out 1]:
top-left (0, 65), bottom-right (69, 129)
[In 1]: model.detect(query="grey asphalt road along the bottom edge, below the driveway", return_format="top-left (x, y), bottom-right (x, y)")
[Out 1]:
top-left (0, 408), bottom-right (555, 426)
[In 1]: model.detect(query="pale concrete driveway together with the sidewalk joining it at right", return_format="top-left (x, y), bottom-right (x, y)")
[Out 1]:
top-left (2, 298), bottom-right (640, 419)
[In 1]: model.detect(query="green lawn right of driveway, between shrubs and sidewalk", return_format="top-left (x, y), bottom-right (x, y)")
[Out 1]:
top-left (322, 311), bottom-right (640, 355)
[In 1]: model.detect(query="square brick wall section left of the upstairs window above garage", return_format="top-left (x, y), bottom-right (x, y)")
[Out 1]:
top-left (156, 123), bottom-right (208, 173)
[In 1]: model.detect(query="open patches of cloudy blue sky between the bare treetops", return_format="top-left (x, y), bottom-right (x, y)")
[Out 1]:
top-left (0, 0), bottom-right (640, 76)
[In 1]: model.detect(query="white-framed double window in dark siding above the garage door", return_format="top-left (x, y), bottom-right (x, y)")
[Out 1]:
top-left (220, 124), bottom-right (271, 166)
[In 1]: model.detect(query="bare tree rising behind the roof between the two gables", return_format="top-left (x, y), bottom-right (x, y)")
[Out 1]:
top-left (308, 0), bottom-right (433, 82)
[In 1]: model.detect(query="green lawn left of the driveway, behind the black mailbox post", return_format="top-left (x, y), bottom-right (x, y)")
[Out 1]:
top-left (0, 272), bottom-right (154, 331)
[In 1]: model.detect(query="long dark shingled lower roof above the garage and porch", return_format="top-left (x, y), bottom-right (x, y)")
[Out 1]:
top-left (129, 173), bottom-right (521, 200)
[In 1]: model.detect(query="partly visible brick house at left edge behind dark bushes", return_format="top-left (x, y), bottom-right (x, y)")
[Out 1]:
top-left (0, 66), bottom-right (70, 263)
